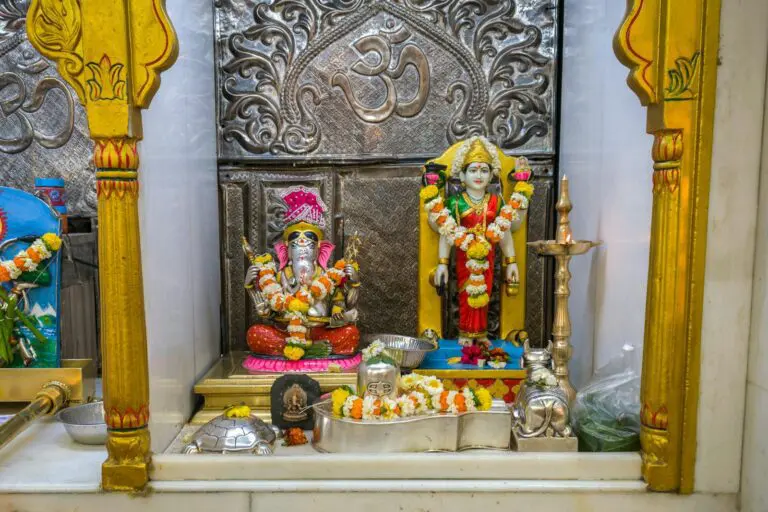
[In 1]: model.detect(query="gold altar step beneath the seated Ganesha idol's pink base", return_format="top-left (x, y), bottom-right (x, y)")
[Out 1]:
top-left (190, 352), bottom-right (357, 425)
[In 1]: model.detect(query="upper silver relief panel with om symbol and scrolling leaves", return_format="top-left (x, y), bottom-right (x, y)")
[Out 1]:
top-left (215, 0), bottom-right (556, 160)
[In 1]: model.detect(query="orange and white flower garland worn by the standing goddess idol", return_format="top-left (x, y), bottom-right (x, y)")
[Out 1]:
top-left (421, 182), bottom-right (533, 309)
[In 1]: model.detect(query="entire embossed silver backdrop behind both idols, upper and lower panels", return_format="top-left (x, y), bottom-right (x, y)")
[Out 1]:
top-left (214, 0), bottom-right (559, 350)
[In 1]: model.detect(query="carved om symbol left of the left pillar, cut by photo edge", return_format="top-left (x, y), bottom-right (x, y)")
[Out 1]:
top-left (0, 72), bottom-right (75, 154)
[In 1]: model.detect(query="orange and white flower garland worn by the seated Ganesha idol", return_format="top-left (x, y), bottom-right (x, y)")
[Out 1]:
top-left (253, 254), bottom-right (347, 361)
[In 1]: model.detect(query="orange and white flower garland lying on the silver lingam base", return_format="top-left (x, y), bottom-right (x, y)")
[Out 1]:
top-left (331, 374), bottom-right (492, 421)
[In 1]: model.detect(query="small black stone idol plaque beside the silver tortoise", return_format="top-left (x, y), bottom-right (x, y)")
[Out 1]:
top-left (270, 374), bottom-right (320, 430)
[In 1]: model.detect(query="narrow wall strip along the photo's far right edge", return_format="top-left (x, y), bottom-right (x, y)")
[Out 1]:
top-left (741, 12), bottom-right (768, 512)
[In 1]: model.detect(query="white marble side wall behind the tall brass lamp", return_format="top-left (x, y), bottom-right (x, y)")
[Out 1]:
top-left (560, 0), bottom-right (653, 389)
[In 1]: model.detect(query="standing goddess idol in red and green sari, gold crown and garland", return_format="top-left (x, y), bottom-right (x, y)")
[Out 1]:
top-left (421, 136), bottom-right (533, 347)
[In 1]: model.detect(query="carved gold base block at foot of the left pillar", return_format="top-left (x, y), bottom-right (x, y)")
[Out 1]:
top-left (101, 427), bottom-right (151, 492)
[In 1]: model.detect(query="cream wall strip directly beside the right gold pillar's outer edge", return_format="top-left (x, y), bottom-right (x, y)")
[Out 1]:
top-left (695, 0), bottom-right (768, 494)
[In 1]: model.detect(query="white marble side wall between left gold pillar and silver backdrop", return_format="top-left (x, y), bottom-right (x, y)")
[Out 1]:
top-left (139, 0), bottom-right (220, 451)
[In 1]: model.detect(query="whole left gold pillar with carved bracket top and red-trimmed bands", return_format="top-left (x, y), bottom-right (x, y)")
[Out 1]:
top-left (27, 0), bottom-right (178, 491)
